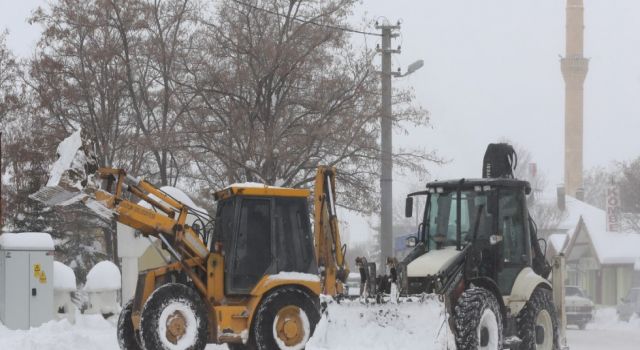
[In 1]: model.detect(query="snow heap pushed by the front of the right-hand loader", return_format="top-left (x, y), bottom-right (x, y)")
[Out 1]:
top-left (306, 299), bottom-right (455, 350)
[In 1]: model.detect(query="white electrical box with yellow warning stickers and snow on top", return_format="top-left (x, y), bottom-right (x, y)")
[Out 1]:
top-left (0, 232), bottom-right (54, 329)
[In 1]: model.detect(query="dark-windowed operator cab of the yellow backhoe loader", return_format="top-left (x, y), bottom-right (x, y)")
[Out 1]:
top-left (210, 184), bottom-right (317, 295)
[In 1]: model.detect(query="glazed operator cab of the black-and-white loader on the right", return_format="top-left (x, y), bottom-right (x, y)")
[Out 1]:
top-left (405, 178), bottom-right (532, 295)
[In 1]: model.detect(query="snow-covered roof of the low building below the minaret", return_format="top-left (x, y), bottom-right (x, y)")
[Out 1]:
top-left (552, 196), bottom-right (640, 265)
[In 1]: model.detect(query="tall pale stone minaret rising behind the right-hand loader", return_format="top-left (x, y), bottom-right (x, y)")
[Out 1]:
top-left (561, 0), bottom-right (589, 196)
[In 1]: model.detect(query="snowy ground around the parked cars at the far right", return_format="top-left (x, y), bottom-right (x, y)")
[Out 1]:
top-left (567, 308), bottom-right (640, 350)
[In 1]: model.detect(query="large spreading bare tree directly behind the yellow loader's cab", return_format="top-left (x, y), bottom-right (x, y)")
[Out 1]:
top-left (185, 0), bottom-right (437, 211)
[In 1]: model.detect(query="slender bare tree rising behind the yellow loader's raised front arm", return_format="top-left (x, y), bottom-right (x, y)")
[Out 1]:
top-left (107, 0), bottom-right (198, 185)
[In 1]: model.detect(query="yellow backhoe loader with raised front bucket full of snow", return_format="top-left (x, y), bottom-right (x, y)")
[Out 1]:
top-left (32, 132), bottom-right (349, 350)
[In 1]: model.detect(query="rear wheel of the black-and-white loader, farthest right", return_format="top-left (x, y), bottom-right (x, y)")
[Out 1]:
top-left (517, 288), bottom-right (560, 350)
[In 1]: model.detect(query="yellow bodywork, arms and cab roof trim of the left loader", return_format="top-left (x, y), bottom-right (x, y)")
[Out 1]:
top-left (84, 167), bottom-right (348, 343)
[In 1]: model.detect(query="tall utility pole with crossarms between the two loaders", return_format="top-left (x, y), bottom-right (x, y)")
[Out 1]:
top-left (376, 23), bottom-right (400, 274)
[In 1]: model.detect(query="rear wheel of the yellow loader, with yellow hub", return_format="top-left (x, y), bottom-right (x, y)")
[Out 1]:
top-left (248, 287), bottom-right (320, 350)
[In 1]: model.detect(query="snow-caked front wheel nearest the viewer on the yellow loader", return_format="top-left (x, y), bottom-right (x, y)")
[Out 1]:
top-left (140, 283), bottom-right (209, 350)
